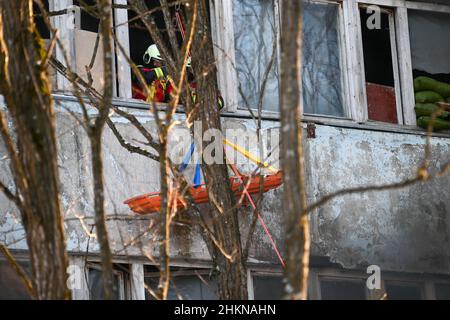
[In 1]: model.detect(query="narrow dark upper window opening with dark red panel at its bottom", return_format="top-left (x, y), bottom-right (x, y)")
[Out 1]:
top-left (360, 7), bottom-right (398, 123)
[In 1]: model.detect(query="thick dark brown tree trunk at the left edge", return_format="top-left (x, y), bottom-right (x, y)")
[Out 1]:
top-left (0, 0), bottom-right (70, 299)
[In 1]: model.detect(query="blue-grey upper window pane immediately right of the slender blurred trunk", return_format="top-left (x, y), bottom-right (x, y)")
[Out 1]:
top-left (302, 2), bottom-right (344, 116)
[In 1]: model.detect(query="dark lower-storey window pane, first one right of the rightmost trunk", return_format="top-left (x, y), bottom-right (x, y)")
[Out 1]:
top-left (320, 278), bottom-right (366, 300)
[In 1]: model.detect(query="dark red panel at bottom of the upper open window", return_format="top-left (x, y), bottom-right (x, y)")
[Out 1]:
top-left (366, 82), bottom-right (398, 123)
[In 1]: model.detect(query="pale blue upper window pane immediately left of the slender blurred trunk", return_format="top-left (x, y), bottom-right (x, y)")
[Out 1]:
top-left (233, 0), bottom-right (279, 111)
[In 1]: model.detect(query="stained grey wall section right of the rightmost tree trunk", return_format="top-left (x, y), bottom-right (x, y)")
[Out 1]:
top-left (307, 126), bottom-right (450, 273)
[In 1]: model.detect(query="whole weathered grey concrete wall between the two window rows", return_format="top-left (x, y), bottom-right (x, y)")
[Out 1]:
top-left (0, 102), bottom-right (450, 273)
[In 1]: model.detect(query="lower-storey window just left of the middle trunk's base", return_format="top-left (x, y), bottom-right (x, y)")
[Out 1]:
top-left (145, 266), bottom-right (218, 300)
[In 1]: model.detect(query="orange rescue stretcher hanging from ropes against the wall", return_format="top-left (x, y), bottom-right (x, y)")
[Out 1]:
top-left (124, 171), bottom-right (283, 214)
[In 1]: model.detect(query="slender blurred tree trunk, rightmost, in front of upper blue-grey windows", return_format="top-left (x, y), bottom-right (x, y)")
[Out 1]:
top-left (280, 1), bottom-right (310, 299)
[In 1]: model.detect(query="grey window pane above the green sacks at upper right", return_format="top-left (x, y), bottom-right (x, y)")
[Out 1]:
top-left (408, 10), bottom-right (450, 84)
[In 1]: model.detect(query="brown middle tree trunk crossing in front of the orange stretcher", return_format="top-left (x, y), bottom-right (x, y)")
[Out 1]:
top-left (190, 0), bottom-right (248, 299)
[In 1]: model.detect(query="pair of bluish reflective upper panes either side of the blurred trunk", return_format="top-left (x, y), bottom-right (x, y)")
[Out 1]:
top-left (233, 0), bottom-right (346, 117)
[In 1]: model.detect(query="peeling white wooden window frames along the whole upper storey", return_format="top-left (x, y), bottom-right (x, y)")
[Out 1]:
top-left (49, 0), bottom-right (450, 131)
